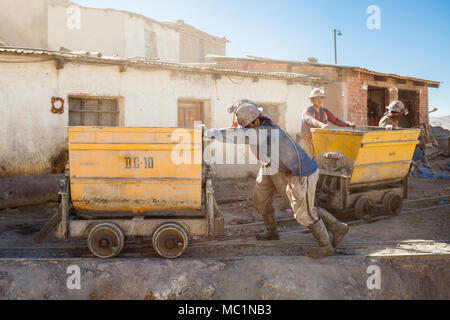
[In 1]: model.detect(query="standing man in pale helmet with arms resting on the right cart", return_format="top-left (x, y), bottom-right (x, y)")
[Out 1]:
top-left (300, 88), bottom-right (355, 157)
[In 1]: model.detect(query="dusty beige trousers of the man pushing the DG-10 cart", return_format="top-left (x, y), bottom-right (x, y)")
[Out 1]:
top-left (253, 169), bottom-right (319, 228)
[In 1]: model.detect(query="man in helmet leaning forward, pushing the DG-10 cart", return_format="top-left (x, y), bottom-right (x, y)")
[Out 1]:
top-left (206, 100), bottom-right (348, 258)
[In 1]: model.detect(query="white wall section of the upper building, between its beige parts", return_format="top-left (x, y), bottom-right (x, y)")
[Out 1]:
top-left (48, 5), bottom-right (180, 62)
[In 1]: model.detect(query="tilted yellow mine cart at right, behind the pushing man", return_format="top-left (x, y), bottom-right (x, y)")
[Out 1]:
top-left (312, 127), bottom-right (420, 219)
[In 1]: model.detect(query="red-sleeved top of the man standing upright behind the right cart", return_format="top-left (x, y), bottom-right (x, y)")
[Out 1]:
top-left (302, 106), bottom-right (350, 140)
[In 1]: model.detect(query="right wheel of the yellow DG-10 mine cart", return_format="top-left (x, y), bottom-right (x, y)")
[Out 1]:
top-left (152, 223), bottom-right (188, 259)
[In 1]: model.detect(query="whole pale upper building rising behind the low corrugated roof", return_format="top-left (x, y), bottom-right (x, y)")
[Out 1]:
top-left (0, 0), bottom-right (228, 63)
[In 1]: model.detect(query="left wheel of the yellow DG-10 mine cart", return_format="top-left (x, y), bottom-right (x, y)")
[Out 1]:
top-left (87, 223), bottom-right (125, 259)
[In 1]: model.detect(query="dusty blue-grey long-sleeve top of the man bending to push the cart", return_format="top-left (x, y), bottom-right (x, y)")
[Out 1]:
top-left (215, 117), bottom-right (318, 177)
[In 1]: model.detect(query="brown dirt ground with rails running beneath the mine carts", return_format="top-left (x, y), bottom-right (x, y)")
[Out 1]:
top-left (0, 156), bottom-right (450, 299)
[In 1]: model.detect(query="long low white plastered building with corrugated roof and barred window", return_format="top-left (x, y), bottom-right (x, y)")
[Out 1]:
top-left (0, 48), bottom-right (324, 177)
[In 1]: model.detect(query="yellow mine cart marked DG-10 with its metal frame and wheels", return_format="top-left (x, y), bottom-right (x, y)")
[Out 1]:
top-left (51, 127), bottom-right (223, 258)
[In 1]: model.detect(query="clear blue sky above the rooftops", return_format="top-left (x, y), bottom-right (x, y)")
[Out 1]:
top-left (74, 0), bottom-right (450, 116)
